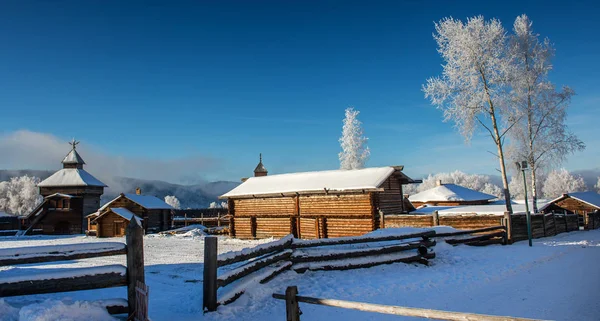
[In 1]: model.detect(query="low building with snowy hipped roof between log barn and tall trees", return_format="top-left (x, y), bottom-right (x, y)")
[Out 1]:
top-left (408, 181), bottom-right (497, 208)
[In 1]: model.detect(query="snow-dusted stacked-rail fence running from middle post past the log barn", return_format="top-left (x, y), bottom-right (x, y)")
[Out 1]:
top-left (203, 231), bottom-right (435, 311)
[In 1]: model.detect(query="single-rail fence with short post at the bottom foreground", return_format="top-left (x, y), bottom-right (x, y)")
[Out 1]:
top-left (273, 286), bottom-right (535, 321)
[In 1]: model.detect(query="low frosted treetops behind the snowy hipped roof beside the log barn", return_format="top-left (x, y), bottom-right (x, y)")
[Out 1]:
top-left (403, 171), bottom-right (503, 198)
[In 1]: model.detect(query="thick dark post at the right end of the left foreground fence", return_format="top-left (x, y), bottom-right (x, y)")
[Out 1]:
top-left (125, 216), bottom-right (146, 314)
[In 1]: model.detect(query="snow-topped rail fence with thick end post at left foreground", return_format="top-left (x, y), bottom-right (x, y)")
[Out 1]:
top-left (0, 216), bottom-right (144, 315)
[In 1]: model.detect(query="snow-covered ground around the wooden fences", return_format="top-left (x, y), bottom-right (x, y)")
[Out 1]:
top-left (0, 229), bottom-right (600, 321)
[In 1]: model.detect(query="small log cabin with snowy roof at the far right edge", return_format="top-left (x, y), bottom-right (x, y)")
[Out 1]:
top-left (540, 192), bottom-right (600, 215)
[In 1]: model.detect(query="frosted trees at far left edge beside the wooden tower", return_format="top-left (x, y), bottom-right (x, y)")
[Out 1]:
top-left (0, 175), bottom-right (43, 215)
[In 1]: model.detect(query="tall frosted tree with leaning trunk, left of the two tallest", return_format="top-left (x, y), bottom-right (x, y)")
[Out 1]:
top-left (423, 16), bottom-right (516, 212)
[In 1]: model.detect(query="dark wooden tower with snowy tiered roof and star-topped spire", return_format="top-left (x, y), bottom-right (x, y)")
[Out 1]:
top-left (25, 140), bottom-right (107, 234)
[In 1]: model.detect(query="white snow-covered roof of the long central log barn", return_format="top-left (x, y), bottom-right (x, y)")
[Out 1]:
top-left (220, 166), bottom-right (404, 198)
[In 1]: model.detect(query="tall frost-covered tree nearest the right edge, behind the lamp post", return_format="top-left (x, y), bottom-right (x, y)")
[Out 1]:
top-left (509, 15), bottom-right (585, 213)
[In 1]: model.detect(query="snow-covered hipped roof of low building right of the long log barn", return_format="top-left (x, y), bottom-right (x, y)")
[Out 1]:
top-left (408, 184), bottom-right (496, 202)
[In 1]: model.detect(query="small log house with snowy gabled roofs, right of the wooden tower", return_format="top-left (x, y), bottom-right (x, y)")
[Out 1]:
top-left (87, 188), bottom-right (173, 237)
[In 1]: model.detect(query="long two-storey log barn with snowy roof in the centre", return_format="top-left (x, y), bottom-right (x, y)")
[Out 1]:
top-left (221, 159), bottom-right (416, 239)
